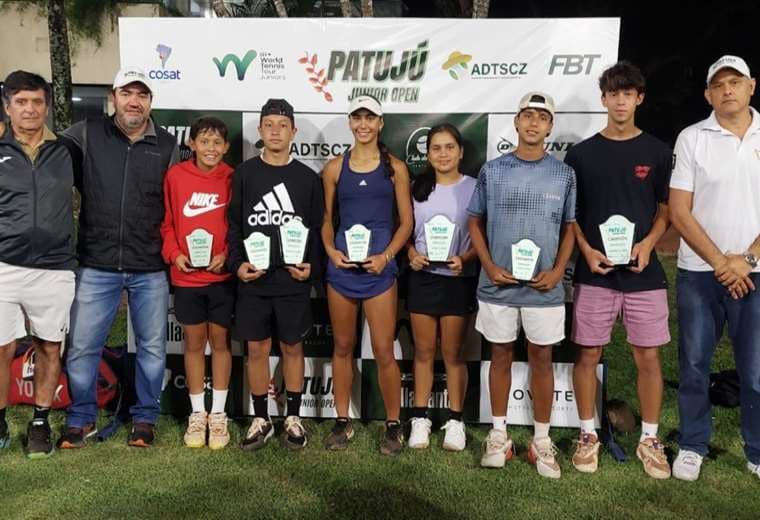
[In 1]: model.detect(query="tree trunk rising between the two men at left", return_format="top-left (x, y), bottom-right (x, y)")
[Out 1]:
top-left (48, 0), bottom-right (71, 132)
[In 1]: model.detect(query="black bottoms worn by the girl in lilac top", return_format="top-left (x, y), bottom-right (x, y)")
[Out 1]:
top-left (406, 271), bottom-right (478, 316)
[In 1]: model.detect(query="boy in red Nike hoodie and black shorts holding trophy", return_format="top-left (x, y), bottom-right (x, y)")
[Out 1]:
top-left (161, 117), bottom-right (235, 450)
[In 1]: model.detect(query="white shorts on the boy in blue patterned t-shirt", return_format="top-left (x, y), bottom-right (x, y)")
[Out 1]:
top-left (475, 300), bottom-right (565, 345)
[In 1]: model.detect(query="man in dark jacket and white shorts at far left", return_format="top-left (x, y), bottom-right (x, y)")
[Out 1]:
top-left (0, 70), bottom-right (74, 458)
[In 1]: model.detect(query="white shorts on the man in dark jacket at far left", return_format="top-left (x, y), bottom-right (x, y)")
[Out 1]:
top-left (0, 262), bottom-right (75, 345)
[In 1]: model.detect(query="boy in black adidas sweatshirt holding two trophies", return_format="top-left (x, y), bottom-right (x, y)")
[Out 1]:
top-left (228, 99), bottom-right (324, 451)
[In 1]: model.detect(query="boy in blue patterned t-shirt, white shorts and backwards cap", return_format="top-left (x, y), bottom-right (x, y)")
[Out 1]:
top-left (467, 92), bottom-right (576, 478)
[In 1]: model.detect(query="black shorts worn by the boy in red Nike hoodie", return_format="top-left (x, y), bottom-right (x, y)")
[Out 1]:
top-left (174, 281), bottom-right (235, 328)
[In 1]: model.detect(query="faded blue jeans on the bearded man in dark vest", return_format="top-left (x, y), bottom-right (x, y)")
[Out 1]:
top-left (66, 267), bottom-right (169, 428)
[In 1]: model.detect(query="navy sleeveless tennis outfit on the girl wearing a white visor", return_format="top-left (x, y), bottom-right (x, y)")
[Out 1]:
top-left (327, 152), bottom-right (398, 299)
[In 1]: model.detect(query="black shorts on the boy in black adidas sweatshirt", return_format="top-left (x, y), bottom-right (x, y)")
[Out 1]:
top-left (235, 291), bottom-right (312, 345)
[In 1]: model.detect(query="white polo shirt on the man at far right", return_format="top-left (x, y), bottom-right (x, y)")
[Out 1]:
top-left (670, 107), bottom-right (760, 272)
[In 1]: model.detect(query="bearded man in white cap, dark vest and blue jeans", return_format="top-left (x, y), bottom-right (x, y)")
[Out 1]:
top-left (58, 67), bottom-right (179, 448)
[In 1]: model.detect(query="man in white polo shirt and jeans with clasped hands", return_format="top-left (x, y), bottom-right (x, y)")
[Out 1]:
top-left (670, 56), bottom-right (760, 480)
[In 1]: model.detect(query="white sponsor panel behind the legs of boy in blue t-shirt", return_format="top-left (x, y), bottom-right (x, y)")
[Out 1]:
top-left (480, 361), bottom-right (605, 428)
